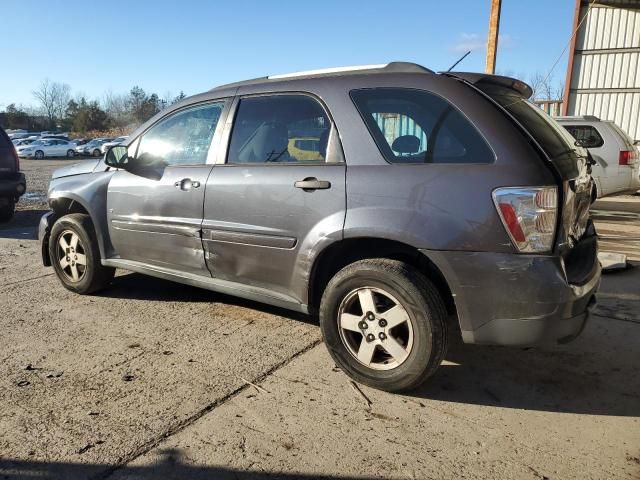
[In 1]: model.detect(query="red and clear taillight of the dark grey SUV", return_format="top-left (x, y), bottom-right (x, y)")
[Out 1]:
top-left (493, 187), bottom-right (558, 253)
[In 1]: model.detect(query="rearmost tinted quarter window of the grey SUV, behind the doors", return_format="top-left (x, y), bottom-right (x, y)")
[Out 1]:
top-left (351, 88), bottom-right (495, 163)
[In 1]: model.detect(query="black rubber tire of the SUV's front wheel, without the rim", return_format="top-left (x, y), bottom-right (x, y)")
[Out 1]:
top-left (49, 213), bottom-right (115, 295)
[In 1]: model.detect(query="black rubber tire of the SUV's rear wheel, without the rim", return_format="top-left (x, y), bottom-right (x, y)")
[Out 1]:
top-left (320, 259), bottom-right (448, 392)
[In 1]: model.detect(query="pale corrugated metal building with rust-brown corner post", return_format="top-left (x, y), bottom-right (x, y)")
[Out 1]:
top-left (563, 0), bottom-right (640, 140)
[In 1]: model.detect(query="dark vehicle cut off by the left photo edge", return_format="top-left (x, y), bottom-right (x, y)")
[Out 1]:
top-left (0, 128), bottom-right (27, 222)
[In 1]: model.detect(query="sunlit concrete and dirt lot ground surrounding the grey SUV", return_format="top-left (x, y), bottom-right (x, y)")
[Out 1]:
top-left (0, 160), bottom-right (640, 479)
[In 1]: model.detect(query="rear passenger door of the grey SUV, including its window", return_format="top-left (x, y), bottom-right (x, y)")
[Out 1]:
top-left (202, 94), bottom-right (346, 303)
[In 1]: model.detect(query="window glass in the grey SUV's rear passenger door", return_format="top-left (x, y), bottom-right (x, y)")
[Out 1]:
top-left (227, 95), bottom-right (331, 164)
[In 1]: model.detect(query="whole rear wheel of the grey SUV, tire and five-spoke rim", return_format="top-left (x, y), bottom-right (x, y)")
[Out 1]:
top-left (320, 259), bottom-right (447, 392)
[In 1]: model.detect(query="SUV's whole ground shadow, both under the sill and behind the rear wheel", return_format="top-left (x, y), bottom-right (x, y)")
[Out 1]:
top-left (101, 274), bottom-right (640, 416)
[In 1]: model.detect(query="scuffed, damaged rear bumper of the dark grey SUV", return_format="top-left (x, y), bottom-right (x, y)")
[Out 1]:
top-left (424, 232), bottom-right (601, 346)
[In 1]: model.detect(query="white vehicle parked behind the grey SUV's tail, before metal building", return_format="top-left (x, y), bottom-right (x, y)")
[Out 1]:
top-left (556, 115), bottom-right (640, 198)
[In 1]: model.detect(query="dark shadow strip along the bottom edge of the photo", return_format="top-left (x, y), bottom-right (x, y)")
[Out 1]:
top-left (0, 450), bottom-right (369, 480)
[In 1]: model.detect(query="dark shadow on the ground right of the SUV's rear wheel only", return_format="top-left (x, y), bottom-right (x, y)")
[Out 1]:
top-left (409, 328), bottom-right (640, 417)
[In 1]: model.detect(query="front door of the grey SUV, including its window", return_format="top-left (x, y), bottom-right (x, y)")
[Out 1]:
top-left (107, 101), bottom-right (225, 276)
